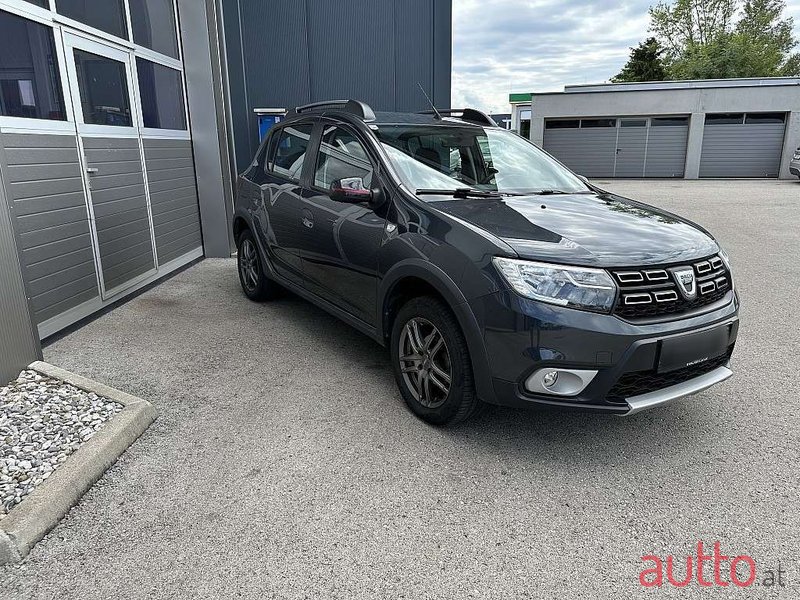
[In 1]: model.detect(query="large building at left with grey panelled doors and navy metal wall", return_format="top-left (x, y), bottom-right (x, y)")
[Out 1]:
top-left (0, 0), bottom-right (450, 380)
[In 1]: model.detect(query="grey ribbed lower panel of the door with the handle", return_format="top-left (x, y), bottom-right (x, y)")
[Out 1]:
top-left (83, 138), bottom-right (155, 290)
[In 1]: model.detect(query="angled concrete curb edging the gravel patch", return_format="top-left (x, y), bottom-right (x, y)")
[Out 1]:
top-left (0, 361), bottom-right (158, 565)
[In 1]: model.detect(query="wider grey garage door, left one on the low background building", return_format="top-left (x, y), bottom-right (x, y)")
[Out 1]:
top-left (544, 116), bottom-right (689, 178)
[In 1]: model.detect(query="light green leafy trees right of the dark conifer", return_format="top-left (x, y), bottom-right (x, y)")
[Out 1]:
top-left (650, 0), bottom-right (800, 79)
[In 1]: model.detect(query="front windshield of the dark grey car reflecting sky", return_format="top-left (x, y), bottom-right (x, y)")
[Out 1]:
top-left (376, 125), bottom-right (590, 194)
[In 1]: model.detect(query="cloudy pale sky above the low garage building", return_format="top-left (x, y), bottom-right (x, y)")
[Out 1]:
top-left (452, 0), bottom-right (800, 112)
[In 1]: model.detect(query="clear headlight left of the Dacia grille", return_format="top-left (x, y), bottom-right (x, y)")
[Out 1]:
top-left (494, 257), bottom-right (617, 313)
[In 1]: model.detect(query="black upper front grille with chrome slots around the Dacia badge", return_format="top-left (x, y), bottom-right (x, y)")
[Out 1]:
top-left (611, 256), bottom-right (731, 320)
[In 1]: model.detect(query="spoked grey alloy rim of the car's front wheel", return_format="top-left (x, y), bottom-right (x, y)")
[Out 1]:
top-left (399, 317), bottom-right (453, 408)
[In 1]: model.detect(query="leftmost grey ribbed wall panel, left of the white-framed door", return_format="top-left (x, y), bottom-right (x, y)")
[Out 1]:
top-left (0, 134), bottom-right (99, 323)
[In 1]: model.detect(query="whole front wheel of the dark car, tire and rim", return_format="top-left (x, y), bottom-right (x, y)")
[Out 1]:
top-left (391, 296), bottom-right (481, 426)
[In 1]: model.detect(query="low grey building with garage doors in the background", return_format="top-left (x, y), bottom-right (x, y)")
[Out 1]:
top-left (511, 77), bottom-right (800, 179)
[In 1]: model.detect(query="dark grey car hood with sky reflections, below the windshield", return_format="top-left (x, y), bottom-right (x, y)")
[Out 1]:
top-left (432, 193), bottom-right (719, 267)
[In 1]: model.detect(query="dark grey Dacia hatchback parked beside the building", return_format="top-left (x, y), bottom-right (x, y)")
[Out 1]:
top-left (233, 101), bottom-right (739, 424)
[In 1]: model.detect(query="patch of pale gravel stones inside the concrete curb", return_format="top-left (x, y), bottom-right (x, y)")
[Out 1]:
top-left (0, 370), bottom-right (123, 519)
